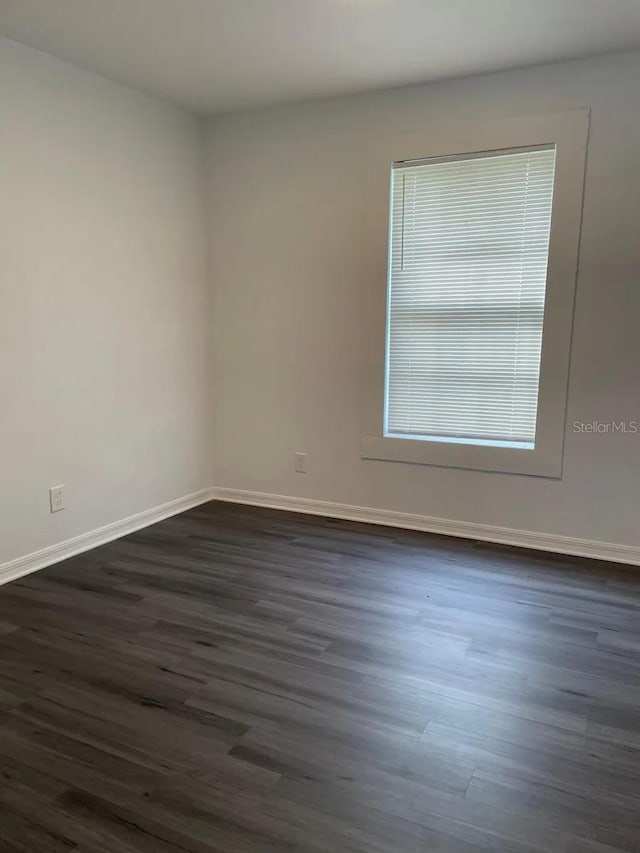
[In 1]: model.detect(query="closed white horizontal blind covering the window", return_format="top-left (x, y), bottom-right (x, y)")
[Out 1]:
top-left (385, 146), bottom-right (555, 447)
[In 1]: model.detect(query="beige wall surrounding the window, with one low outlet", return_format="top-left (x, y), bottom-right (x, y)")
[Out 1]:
top-left (208, 54), bottom-right (640, 546)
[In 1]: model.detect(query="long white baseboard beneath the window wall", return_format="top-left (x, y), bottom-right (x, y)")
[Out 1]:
top-left (212, 488), bottom-right (640, 566)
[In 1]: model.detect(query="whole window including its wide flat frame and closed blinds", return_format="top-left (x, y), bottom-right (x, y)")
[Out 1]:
top-left (362, 110), bottom-right (588, 477)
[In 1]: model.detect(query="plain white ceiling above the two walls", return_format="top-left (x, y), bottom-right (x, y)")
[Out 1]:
top-left (0, 0), bottom-right (640, 113)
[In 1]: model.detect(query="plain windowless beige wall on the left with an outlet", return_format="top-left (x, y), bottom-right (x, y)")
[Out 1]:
top-left (0, 40), bottom-right (211, 564)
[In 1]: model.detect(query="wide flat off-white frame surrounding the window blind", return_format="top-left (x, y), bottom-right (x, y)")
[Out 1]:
top-left (361, 109), bottom-right (590, 479)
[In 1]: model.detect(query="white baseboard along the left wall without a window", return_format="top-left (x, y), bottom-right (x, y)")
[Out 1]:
top-left (0, 489), bottom-right (216, 585)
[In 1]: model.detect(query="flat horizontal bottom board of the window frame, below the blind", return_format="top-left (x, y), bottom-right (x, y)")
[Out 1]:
top-left (360, 435), bottom-right (562, 479)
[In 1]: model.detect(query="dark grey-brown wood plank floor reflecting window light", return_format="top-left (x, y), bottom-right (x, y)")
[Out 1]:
top-left (0, 503), bottom-right (640, 853)
